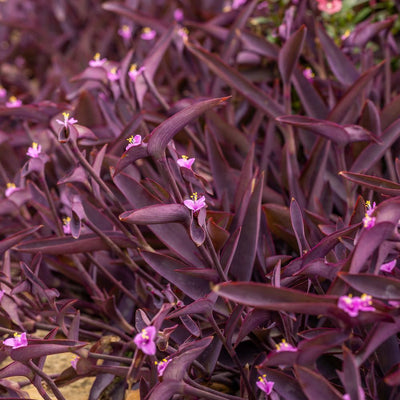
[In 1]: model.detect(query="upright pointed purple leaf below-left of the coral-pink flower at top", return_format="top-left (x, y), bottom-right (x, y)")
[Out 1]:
top-left (278, 25), bottom-right (307, 84)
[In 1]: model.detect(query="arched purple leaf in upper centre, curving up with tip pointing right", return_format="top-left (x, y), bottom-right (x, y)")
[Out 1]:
top-left (147, 97), bottom-right (229, 159)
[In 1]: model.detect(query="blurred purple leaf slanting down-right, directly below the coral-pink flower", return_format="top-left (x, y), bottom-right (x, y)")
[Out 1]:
top-left (317, 25), bottom-right (359, 86)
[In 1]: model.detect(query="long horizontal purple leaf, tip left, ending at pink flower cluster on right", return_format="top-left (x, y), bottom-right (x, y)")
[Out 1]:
top-left (213, 282), bottom-right (337, 315)
